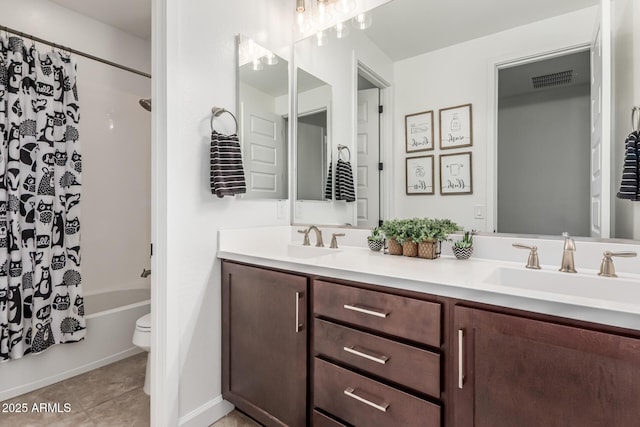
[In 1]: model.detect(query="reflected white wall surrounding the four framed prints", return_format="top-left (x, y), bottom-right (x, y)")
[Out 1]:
top-left (392, 7), bottom-right (597, 231)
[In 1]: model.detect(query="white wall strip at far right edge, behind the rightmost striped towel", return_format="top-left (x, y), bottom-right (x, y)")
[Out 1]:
top-left (611, 0), bottom-right (640, 239)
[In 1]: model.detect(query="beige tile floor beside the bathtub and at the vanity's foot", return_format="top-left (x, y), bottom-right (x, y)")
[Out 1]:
top-left (0, 353), bottom-right (259, 427)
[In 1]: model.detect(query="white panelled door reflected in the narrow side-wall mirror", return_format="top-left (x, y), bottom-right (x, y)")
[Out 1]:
top-left (240, 103), bottom-right (287, 199)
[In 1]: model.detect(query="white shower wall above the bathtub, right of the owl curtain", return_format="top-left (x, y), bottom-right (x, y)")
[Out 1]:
top-left (0, 0), bottom-right (151, 294)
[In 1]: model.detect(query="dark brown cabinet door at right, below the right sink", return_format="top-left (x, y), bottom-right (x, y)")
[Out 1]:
top-left (453, 307), bottom-right (640, 427)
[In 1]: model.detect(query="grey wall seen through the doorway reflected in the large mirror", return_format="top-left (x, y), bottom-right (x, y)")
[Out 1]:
top-left (498, 84), bottom-right (591, 236)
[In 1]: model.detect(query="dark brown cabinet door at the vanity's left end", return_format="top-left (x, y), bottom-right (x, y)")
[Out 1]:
top-left (222, 262), bottom-right (308, 427)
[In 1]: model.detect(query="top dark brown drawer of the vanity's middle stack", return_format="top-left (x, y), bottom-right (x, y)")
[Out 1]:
top-left (313, 280), bottom-right (440, 347)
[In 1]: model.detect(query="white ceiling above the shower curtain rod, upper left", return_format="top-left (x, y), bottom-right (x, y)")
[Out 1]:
top-left (49, 0), bottom-right (151, 40)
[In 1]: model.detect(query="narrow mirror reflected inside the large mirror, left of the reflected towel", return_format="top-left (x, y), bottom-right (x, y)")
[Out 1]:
top-left (296, 68), bottom-right (331, 200)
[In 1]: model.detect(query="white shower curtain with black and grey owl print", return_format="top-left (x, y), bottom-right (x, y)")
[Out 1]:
top-left (0, 37), bottom-right (85, 361)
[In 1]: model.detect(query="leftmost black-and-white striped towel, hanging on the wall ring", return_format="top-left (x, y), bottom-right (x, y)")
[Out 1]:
top-left (209, 131), bottom-right (247, 197)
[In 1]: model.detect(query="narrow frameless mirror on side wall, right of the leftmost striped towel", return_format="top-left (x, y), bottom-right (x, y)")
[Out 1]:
top-left (237, 35), bottom-right (289, 199)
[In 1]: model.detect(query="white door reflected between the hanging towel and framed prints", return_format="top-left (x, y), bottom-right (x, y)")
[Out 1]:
top-left (356, 88), bottom-right (380, 228)
